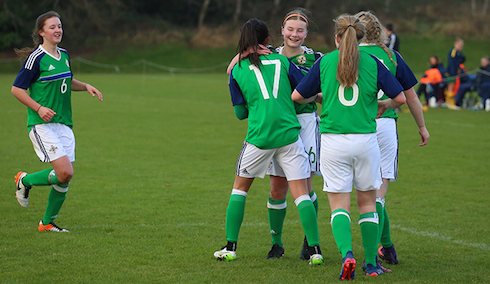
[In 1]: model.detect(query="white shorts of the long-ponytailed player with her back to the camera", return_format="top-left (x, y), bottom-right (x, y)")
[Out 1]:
top-left (320, 133), bottom-right (382, 192)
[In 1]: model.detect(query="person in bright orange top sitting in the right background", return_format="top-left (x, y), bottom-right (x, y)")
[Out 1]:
top-left (417, 55), bottom-right (444, 107)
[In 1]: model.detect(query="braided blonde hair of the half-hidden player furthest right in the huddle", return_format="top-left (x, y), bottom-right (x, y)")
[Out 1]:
top-left (356, 11), bottom-right (397, 66)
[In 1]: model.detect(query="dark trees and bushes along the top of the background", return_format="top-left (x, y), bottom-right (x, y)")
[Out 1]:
top-left (0, 0), bottom-right (490, 50)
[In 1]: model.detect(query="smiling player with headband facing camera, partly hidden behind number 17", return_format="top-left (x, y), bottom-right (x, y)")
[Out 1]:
top-left (227, 8), bottom-right (322, 259)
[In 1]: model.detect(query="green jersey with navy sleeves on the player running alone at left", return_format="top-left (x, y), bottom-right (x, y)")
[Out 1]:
top-left (14, 45), bottom-right (73, 128)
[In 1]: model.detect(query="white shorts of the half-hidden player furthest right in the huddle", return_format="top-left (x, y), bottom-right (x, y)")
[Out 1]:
top-left (376, 117), bottom-right (398, 181)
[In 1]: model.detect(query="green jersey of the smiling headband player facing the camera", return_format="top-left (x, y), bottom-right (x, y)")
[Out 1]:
top-left (276, 46), bottom-right (322, 114)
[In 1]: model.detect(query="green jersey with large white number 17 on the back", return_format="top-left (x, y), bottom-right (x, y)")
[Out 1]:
top-left (230, 54), bottom-right (303, 149)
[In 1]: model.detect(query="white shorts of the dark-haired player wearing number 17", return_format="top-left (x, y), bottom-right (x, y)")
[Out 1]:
top-left (235, 137), bottom-right (310, 181)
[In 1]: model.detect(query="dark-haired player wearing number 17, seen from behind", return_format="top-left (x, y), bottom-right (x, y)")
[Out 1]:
top-left (214, 19), bottom-right (323, 264)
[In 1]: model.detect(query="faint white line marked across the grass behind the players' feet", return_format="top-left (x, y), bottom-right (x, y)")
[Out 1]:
top-left (14, 221), bottom-right (490, 251)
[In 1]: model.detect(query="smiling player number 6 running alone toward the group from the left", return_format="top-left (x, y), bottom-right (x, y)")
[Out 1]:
top-left (12, 11), bottom-right (102, 232)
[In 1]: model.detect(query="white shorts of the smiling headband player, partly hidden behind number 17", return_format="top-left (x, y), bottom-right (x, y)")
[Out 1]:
top-left (267, 112), bottom-right (321, 177)
